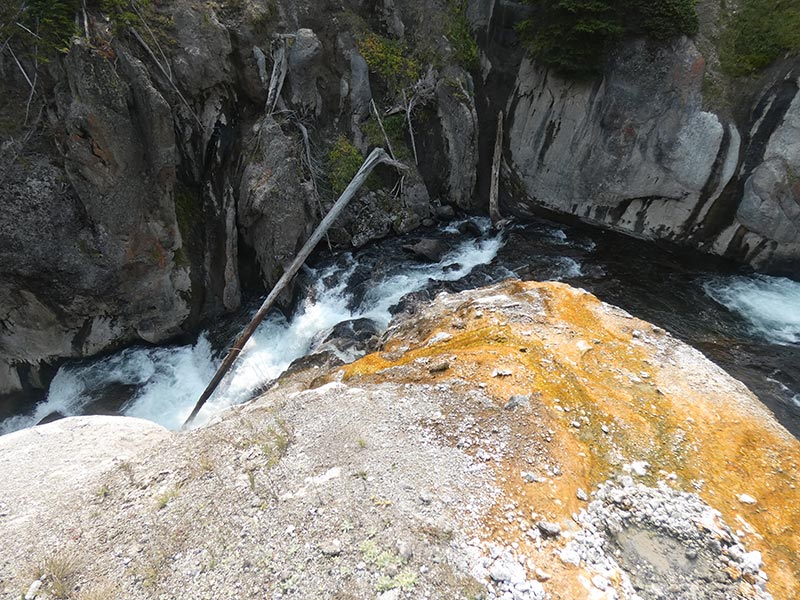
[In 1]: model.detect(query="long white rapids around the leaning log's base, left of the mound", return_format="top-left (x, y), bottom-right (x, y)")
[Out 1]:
top-left (0, 219), bottom-right (504, 434)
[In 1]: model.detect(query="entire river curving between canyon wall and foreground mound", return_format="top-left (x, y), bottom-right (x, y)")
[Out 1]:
top-left (0, 219), bottom-right (800, 435)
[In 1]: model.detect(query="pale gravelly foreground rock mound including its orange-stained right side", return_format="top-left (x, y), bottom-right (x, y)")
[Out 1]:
top-left (0, 282), bottom-right (800, 600)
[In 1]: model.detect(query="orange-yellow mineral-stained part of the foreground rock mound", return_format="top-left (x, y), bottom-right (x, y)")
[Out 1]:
top-left (345, 281), bottom-right (800, 598)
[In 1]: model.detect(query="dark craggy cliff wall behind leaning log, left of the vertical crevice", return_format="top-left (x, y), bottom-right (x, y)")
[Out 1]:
top-left (0, 0), bottom-right (477, 393)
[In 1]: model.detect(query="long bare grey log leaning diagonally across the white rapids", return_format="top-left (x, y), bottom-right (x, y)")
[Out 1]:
top-left (183, 148), bottom-right (406, 427)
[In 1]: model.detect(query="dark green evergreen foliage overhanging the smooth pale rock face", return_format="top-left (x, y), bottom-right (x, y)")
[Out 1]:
top-left (517, 0), bottom-right (698, 77)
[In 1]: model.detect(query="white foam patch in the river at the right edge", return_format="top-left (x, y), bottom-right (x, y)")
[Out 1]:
top-left (702, 275), bottom-right (800, 344)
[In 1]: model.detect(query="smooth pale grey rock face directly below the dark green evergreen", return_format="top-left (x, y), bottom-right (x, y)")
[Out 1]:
top-left (508, 39), bottom-right (740, 248)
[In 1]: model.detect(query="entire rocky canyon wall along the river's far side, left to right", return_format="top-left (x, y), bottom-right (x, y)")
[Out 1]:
top-left (0, 0), bottom-right (800, 418)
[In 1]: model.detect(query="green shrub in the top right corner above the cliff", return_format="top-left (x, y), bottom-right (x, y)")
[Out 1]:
top-left (720, 0), bottom-right (800, 77)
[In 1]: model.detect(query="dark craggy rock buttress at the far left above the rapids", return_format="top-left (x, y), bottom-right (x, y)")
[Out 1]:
top-left (0, 45), bottom-right (190, 388)
